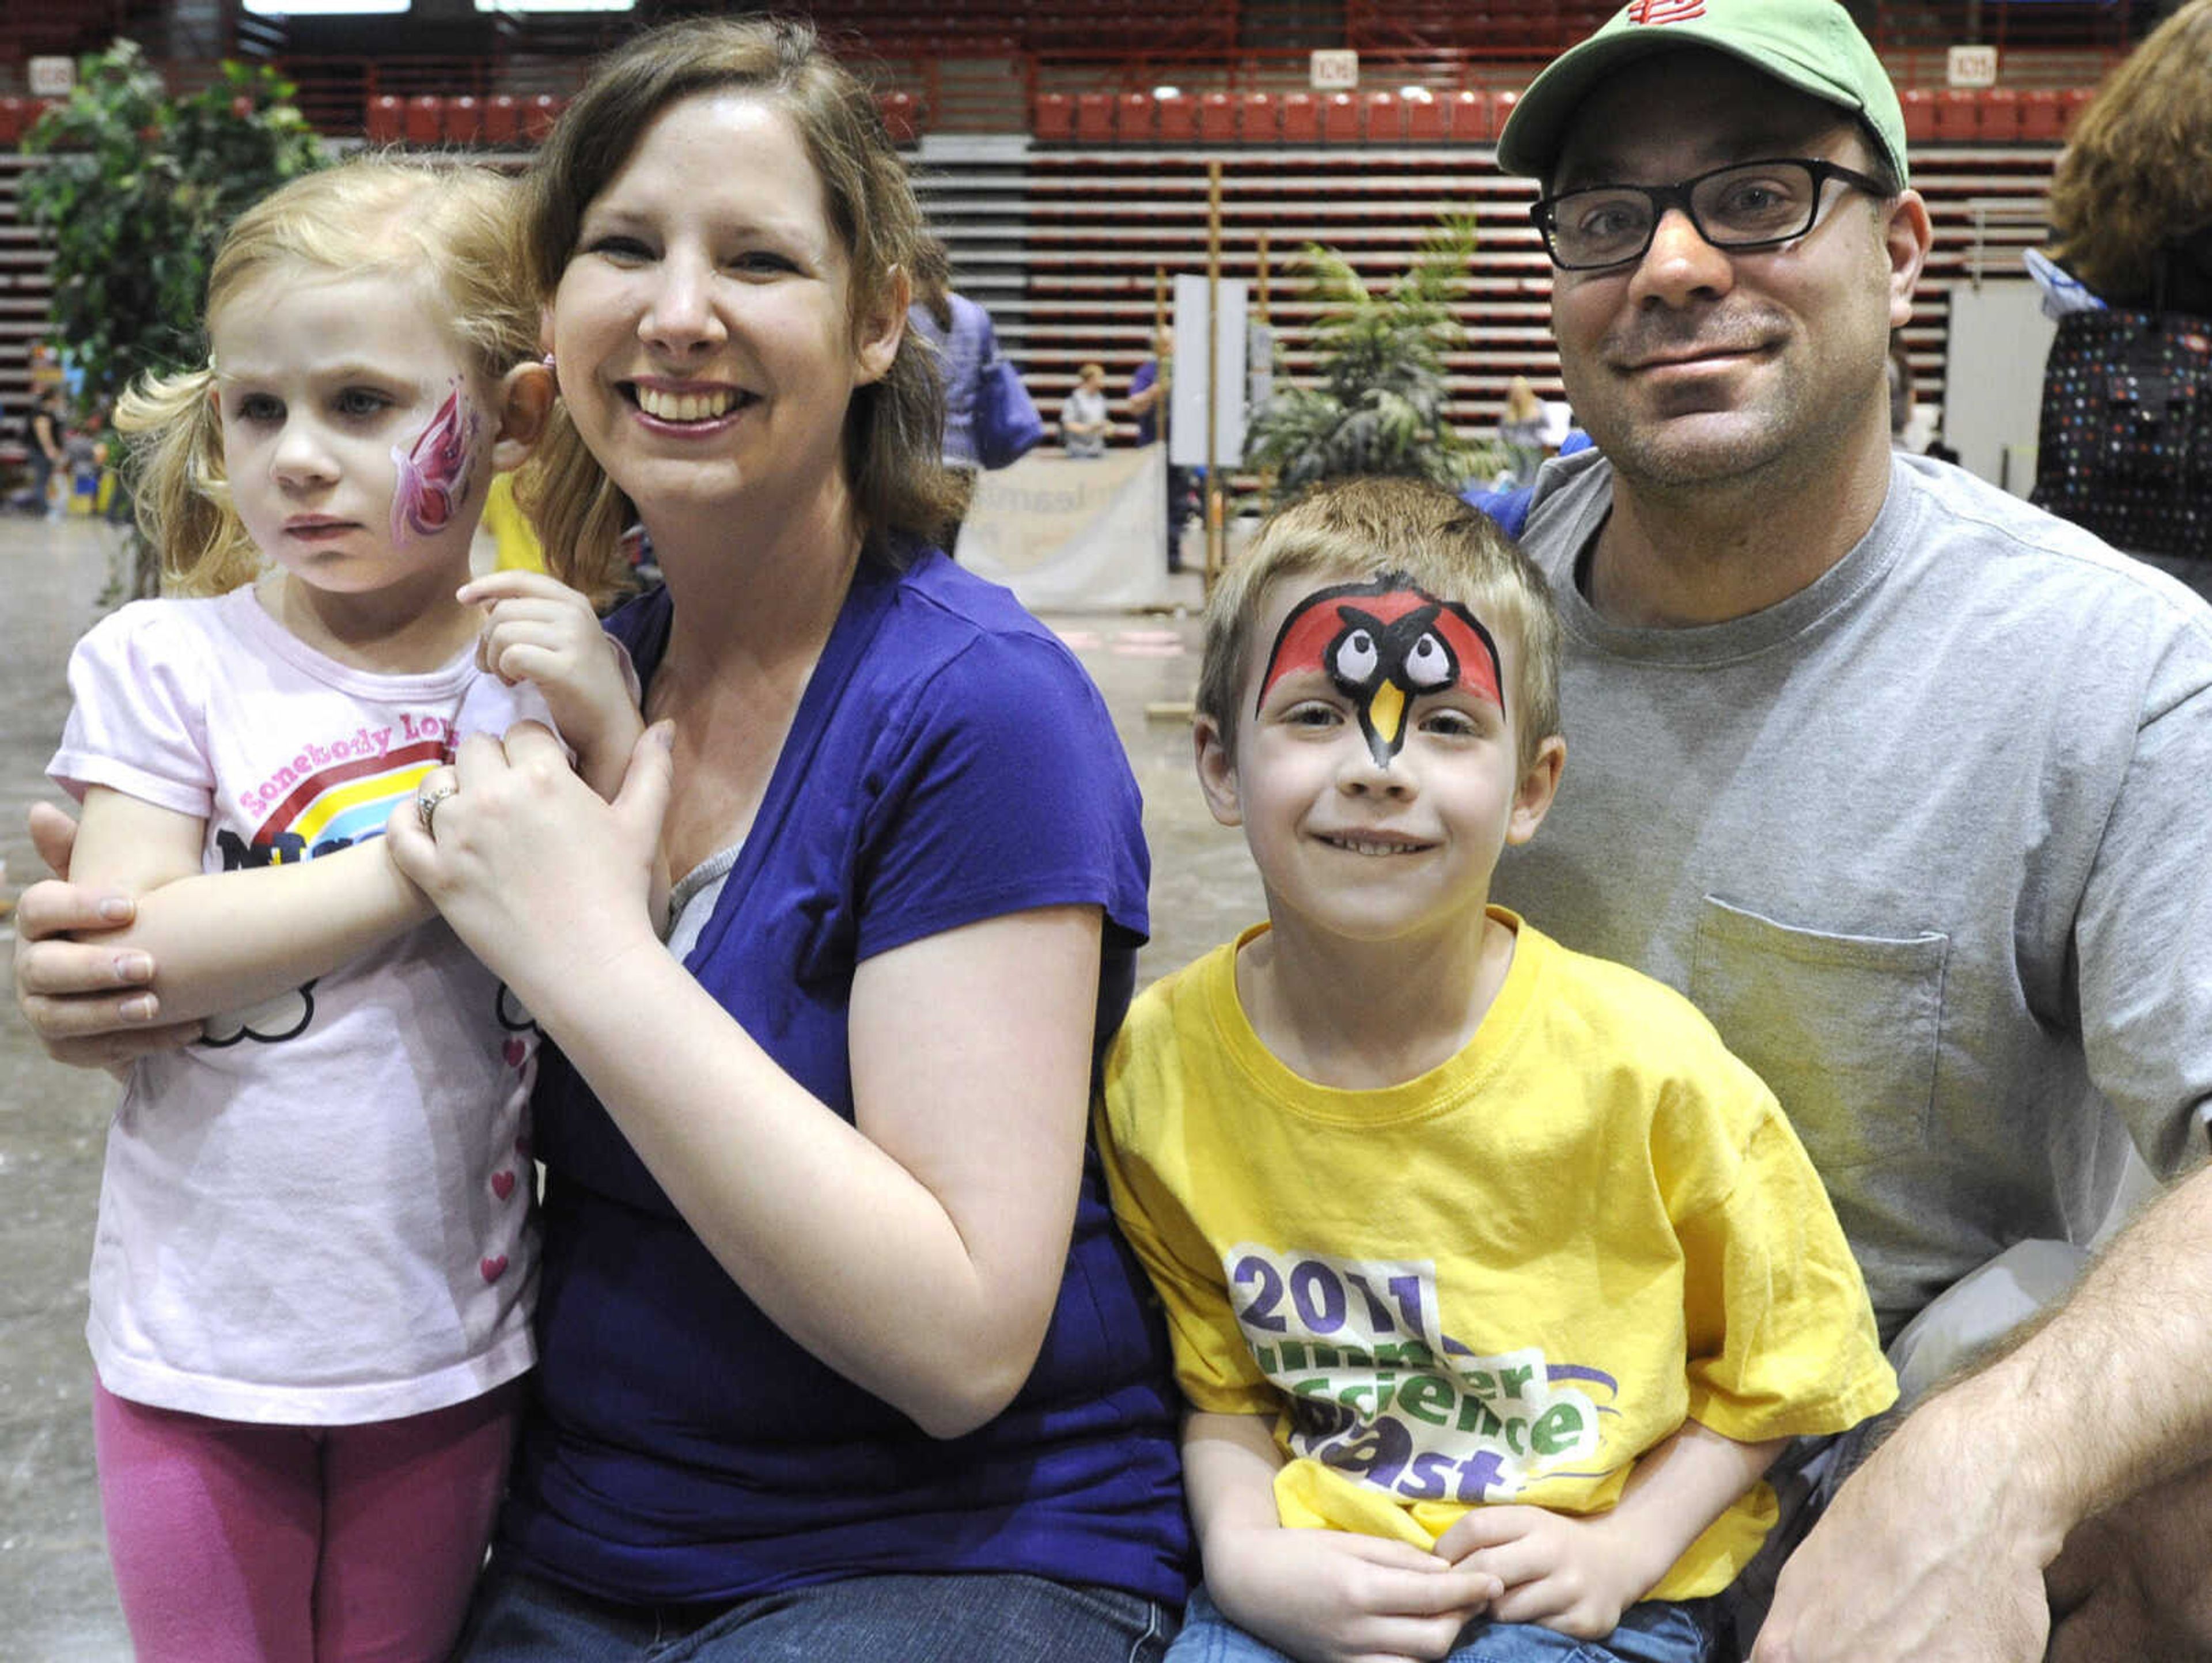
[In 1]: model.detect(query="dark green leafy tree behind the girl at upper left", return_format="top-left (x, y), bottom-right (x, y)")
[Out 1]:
top-left (20, 40), bottom-right (325, 597)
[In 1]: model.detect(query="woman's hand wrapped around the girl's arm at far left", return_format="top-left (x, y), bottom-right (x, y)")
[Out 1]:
top-left (16, 803), bottom-right (199, 1070)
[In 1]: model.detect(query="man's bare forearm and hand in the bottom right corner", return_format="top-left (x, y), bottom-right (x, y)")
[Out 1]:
top-left (1752, 1168), bottom-right (2212, 1663)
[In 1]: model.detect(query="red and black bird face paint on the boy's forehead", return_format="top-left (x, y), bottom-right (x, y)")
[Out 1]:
top-left (1259, 573), bottom-right (1506, 767)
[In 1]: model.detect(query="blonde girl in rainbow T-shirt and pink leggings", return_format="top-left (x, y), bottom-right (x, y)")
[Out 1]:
top-left (48, 161), bottom-right (639, 1663)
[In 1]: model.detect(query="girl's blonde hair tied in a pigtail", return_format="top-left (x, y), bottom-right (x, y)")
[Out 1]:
top-left (115, 155), bottom-right (537, 595)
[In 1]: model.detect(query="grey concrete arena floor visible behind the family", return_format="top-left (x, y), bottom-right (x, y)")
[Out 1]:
top-left (0, 516), bottom-right (1261, 1663)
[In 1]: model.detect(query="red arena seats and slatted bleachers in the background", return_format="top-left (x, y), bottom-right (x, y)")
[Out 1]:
top-left (0, 11), bottom-right (2112, 449)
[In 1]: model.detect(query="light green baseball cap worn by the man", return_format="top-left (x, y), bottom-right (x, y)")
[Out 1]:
top-left (1498, 0), bottom-right (1909, 184)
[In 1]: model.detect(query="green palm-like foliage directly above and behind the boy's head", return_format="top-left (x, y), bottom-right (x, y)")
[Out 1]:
top-left (1245, 217), bottom-right (1495, 500)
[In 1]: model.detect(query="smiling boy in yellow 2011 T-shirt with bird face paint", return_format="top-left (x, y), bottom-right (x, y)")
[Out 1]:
top-left (1099, 480), bottom-right (1896, 1663)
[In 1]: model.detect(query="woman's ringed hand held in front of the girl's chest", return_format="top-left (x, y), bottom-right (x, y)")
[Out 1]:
top-left (385, 721), bottom-right (671, 1009)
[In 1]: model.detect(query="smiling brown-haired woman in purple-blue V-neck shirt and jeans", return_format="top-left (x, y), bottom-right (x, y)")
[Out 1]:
top-left (18, 20), bottom-right (1188, 1663)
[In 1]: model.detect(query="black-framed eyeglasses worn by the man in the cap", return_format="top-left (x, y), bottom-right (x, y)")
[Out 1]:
top-left (1528, 157), bottom-right (1896, 272)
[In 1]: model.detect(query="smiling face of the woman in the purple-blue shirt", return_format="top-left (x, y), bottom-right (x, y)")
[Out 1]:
top-left (546, 90), bottom-right (903, 524)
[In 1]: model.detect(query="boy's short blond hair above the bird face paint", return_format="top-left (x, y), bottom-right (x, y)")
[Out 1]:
top-left (1196, 478), bottom-right (1559, 770)
